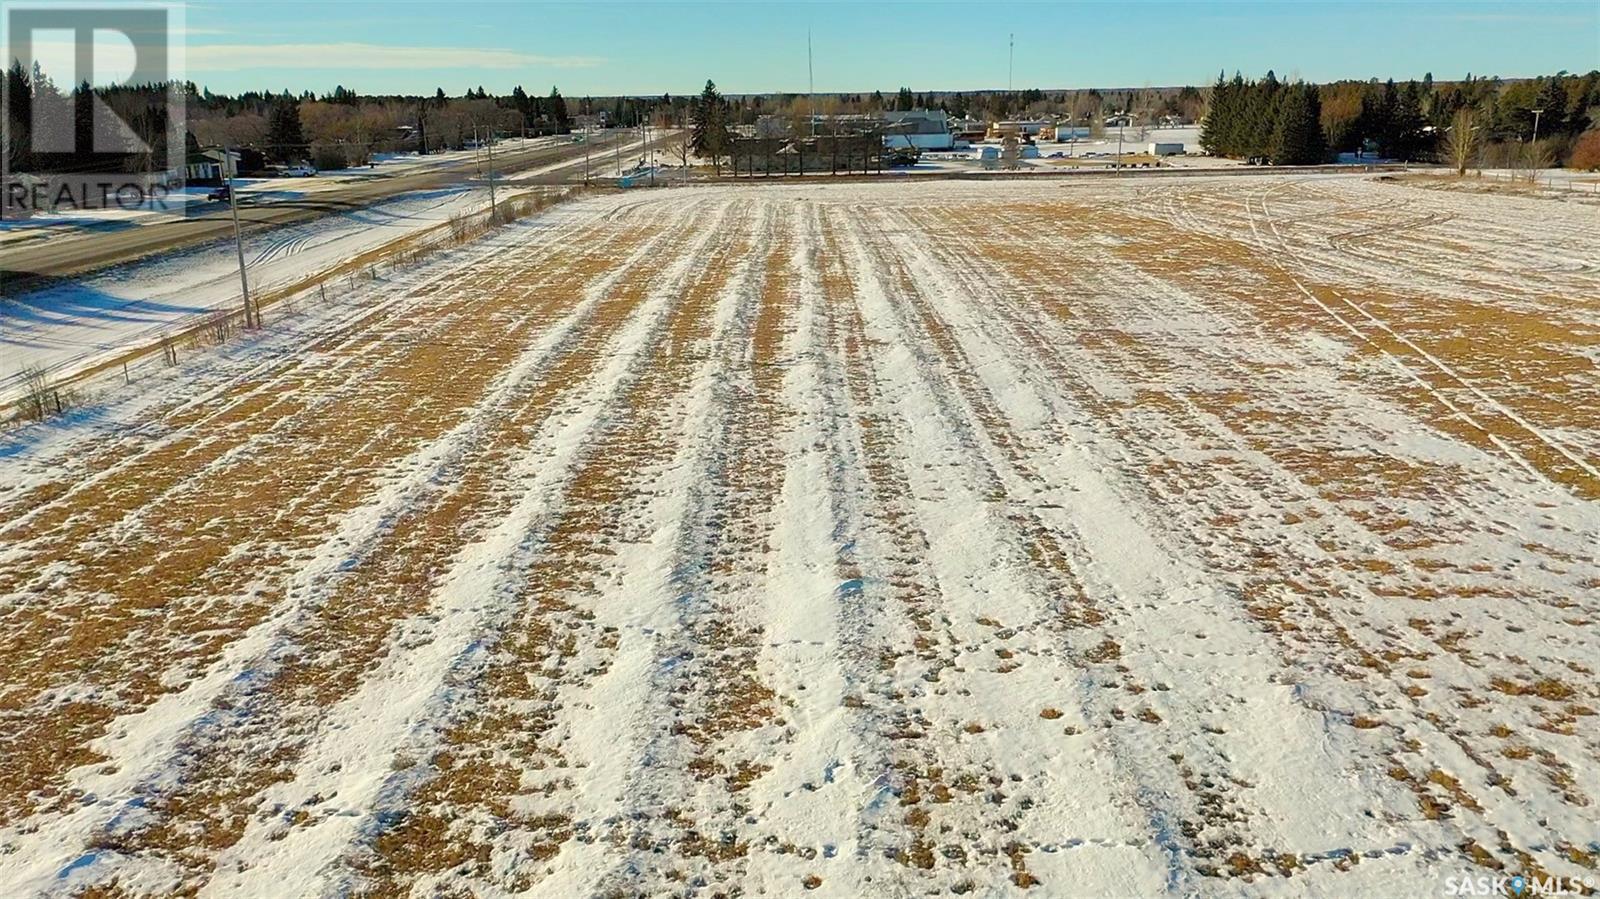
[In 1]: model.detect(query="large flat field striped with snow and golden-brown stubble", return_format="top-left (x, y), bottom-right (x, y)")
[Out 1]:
top-left (0, 171), bottom-right (1600, 897)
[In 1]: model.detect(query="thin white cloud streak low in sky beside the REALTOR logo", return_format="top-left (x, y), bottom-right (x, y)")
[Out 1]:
top-left (187, 43), bottom-right (605, 72)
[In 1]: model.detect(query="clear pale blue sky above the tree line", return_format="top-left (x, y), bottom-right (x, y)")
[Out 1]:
top-left (178, 0), bottom-right (1600, 96)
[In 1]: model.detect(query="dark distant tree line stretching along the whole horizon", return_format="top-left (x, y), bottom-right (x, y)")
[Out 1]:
top-left (12, 64), bottom-right (1600, 171)
